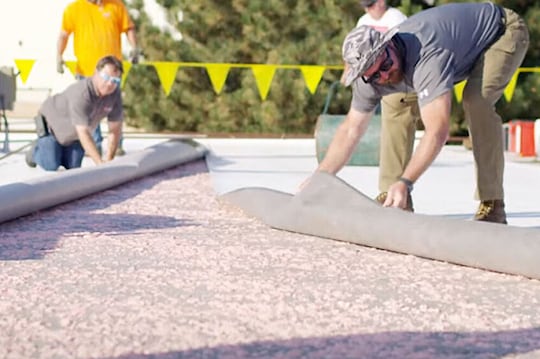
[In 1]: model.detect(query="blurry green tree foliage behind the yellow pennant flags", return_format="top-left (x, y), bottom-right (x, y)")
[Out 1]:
top-left (125, 0), bottom-right (540, 134)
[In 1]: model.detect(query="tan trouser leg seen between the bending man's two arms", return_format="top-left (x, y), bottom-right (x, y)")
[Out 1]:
top-left (379, 92), bottom-right (420, 192)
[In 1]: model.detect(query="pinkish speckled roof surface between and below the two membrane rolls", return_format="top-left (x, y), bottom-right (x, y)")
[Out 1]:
top-left (0, 161), bottom-right (540, 359)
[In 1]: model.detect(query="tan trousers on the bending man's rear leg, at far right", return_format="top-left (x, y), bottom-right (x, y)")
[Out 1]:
top-left (463, 9), bottom-right (529, 201)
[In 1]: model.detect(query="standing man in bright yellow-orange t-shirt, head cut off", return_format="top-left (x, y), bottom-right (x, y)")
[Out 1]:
top-left (57, 0), bottom-right (140, 156)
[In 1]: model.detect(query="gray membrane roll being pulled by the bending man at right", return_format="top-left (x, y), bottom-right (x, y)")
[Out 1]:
top-left (221, 172), bottom-right (540, 279)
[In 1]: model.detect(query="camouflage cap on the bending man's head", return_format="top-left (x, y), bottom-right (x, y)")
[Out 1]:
top-left (342, 25), bottom-right (399, 86)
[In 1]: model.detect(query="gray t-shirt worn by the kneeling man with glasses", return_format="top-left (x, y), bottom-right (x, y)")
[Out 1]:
top-left (39, 78), bottom-right (124, 145)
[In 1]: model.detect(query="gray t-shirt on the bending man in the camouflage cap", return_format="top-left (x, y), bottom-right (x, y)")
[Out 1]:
top-left (352, 3), bottom-right (501, 112)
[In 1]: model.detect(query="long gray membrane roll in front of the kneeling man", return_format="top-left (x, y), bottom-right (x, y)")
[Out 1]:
top-left (0, 140), bottom-right (207, 223)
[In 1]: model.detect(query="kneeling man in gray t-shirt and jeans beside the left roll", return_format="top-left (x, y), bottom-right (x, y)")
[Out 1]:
top-left (27, 56), bottom-right (123, 171)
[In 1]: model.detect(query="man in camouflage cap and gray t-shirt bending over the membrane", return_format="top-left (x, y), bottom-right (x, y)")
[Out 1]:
top-left (312, 3), bottom-right (529, 223)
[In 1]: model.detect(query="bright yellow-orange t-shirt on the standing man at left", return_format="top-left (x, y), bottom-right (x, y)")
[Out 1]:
top-left (62, 0), bottom-right (134, 77)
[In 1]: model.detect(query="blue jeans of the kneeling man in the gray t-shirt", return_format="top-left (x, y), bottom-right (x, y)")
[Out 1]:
top-left (33, 135), bottom-right (84, 171)
